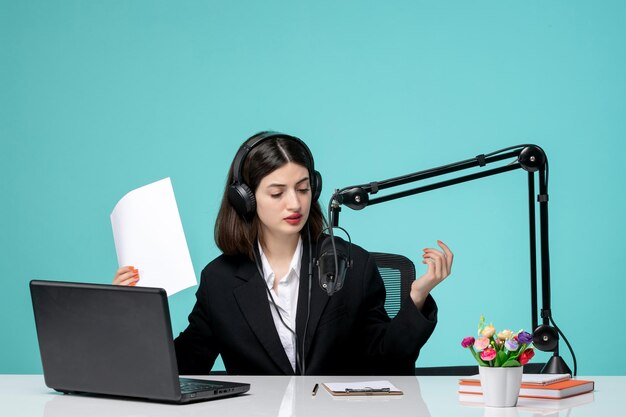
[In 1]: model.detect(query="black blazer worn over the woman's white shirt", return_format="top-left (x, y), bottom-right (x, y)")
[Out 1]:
top-left (174, 237), bottom-right (437, 375)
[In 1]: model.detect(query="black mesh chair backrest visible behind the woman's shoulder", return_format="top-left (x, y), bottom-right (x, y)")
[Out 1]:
top-left (371, 252), bottom-right (415, 318)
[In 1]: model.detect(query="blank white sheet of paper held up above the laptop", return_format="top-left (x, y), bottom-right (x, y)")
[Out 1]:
top-left (111, 178), bottom-right (197, 296)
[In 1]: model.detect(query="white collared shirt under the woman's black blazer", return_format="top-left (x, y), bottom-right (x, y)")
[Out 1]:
top-left (257, 238), bottom-right (302, 372)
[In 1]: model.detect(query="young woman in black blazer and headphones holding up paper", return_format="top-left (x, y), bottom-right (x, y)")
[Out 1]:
top-left (113, 132), bottom-right (453, 375)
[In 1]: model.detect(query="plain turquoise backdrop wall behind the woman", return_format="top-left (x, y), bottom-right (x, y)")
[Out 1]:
top-left (0, 0), bottom-right (626, 375)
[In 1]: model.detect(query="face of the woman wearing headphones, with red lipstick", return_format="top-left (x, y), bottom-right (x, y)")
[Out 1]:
top-left (255, 162), bottom-right (311, 239)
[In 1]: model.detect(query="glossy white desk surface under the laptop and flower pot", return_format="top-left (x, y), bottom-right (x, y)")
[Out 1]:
top-left (0, 375), bottom-right (626, 417)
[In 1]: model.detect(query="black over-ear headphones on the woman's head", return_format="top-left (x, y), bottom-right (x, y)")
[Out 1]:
top-left (228, 131), bottom-right (322, 220)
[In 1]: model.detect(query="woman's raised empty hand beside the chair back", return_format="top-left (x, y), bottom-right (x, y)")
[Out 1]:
top-left (411, 240), bottom-right (454, 310)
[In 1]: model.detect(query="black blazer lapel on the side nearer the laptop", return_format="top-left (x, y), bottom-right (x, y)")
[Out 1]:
top-left (234, 262), bottom-right (294, 375)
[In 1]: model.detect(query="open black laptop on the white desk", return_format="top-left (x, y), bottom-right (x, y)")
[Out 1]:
top-left (30, 280), bottom-right (250, 404)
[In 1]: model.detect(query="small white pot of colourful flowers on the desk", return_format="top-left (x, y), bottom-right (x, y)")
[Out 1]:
top-left (461, 316), bottom-right (535, 407)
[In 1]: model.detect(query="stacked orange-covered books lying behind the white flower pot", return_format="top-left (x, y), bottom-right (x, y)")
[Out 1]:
top-left (459, 374), bottom-right (594, 403)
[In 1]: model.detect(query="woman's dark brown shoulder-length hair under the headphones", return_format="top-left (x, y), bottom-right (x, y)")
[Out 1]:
top-left (215, 132), bottom-right (326, 260)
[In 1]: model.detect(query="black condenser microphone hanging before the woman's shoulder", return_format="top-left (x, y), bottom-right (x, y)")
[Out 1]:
top-left (317, 236), bottom-right (352, 296)
